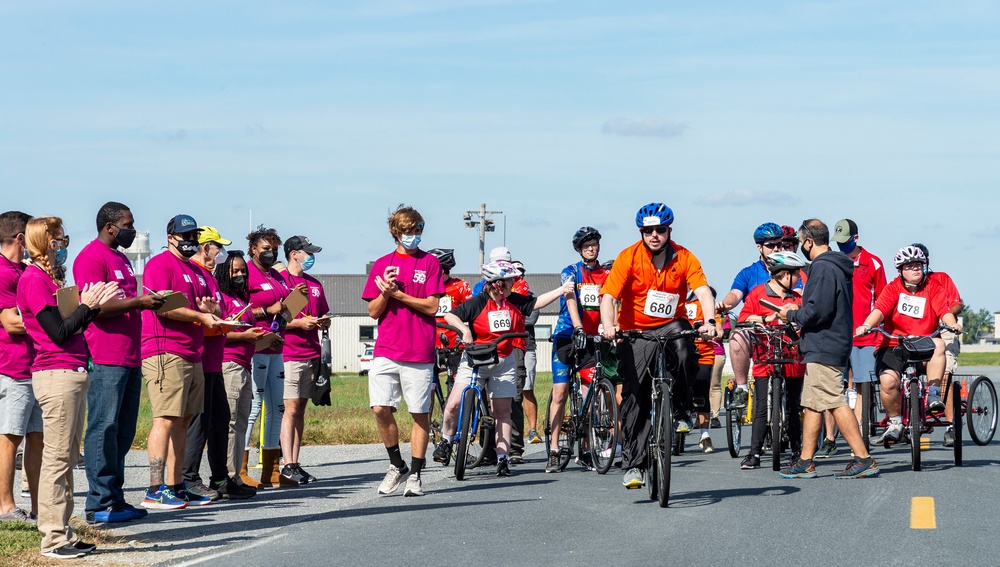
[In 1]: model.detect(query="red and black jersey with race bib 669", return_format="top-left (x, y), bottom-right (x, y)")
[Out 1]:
top-left (451, 292), bottom-right (535, 358)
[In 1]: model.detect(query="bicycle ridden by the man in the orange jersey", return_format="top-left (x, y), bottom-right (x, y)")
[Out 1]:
top-left (617, 330), bottom-right (698, 508)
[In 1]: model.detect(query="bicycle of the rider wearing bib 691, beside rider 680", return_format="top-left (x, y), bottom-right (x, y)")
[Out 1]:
top-left (545, 335), bottom-right (618, 474)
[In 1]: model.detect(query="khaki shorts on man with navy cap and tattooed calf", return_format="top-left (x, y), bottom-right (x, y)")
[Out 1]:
top-left (142, 353), bottom-right (205, 417)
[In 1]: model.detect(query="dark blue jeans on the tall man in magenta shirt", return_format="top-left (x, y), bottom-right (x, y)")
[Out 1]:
top-left (83, 364), bottom-right (142, 512)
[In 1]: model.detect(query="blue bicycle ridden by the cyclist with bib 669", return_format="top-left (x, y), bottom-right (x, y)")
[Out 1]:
top-left (452, 333), bottom-right (528, 480)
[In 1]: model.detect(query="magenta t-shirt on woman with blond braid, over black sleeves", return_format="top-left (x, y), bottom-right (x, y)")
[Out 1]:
top-left (17, 266), bottom-right (87, 372)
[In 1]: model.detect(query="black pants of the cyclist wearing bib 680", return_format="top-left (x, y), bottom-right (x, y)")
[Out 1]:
top-left (618, 320), bottom-right (698, 469)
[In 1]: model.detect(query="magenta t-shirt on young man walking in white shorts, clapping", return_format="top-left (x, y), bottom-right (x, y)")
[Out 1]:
top-left (361, 250), bottom-right (444, 363)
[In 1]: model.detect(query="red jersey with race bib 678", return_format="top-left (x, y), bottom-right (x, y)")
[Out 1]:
top-left (875, 277), bottom-right (948, 348)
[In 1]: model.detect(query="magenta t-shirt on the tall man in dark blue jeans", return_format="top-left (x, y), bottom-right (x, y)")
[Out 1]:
top-left (73, 238), bottom-right (142, 368)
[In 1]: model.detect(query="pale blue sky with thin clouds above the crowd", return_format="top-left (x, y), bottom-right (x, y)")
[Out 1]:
top-left (0, 0), bottom-right (1000, 311)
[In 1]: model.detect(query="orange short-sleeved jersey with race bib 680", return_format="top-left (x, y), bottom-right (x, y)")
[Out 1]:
top-left (601, 241), bottom-right (708, 330)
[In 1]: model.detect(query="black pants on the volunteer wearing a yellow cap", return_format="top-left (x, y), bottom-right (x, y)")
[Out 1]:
top-left (184, 372), bottom-right (229, 485)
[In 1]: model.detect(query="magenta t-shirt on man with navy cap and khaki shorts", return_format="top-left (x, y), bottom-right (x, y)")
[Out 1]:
top-left (142, 250), bottom-right (209, 362)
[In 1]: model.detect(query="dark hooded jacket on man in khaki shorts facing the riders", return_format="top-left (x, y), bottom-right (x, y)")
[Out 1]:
top-left (788, 250), bottom-right (854, 367)
